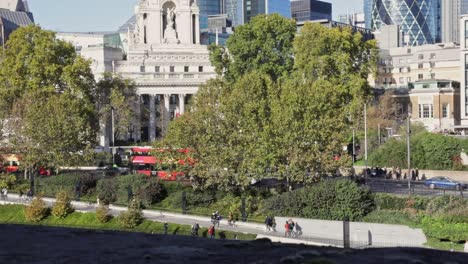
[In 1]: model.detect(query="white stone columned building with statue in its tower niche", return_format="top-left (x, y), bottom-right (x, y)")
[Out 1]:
top-left (57, 0), bottom-right (216, 147)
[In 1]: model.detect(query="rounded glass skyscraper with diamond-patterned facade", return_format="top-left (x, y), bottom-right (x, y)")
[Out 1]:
top-left (364, 0), bottom-right (441, 46)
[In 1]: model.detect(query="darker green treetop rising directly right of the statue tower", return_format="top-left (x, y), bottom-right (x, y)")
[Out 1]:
top-left (210, 14), bottom-right (296, 81)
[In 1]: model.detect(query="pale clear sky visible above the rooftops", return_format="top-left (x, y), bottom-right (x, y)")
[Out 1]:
top-left (28, 0), bottom-right (363, 32)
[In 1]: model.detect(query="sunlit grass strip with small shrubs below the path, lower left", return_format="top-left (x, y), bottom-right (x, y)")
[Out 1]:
top-left (0, 205), bottom-right (256, 240)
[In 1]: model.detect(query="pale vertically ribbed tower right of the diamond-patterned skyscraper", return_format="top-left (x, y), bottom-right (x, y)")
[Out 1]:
top-left (440, 0), bottom-right (468, 43)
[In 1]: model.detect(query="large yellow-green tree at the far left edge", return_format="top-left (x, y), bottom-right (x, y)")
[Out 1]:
top-left (0, 26), bottom-right (97, 168)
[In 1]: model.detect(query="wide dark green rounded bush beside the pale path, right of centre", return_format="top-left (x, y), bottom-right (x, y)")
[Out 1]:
top-left (265, 180), bottom-right (374, 220)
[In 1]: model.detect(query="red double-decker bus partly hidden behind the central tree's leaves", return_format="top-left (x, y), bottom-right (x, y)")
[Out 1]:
top-left (130, 147), bottom-right (194, 181)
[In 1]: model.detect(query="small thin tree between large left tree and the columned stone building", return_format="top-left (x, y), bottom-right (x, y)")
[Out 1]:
top-left (96, 73), bottom-right (137, 142)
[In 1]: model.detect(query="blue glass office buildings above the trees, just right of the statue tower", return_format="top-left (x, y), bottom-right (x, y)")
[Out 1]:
top-left (223, 0), bottom-right (291, 27)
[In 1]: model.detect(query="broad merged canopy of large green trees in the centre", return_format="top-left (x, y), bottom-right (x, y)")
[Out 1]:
top-left (163, 15), bottom-right (376, 189)
